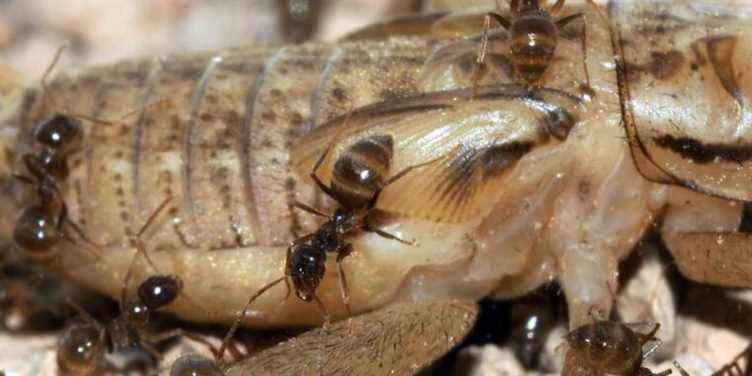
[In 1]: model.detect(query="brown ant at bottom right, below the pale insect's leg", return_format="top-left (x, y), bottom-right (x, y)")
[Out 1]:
top-left (562, 321), bottom-right (671, 376)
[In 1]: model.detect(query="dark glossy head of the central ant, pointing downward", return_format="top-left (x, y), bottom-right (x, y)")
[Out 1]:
top-left (287, 243), bottom-right (326, 302)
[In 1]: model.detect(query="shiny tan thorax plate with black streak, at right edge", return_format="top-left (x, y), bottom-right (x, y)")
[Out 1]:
top-left (612, 4), bottom-right (752, 201)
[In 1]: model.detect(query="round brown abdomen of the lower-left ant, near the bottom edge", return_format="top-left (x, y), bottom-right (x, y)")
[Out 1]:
top-left (57, 323), bottom-right (105, 375)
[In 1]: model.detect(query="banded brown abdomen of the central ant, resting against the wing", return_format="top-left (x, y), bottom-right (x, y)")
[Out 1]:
top-left (331, 135), bottom-right (394, 208)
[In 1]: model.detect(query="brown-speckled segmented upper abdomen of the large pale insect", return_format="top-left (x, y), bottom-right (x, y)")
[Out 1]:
top-left (14, 40), bottom-right (431, 249)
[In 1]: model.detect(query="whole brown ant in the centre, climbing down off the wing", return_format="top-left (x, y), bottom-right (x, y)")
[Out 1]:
top-left (219, 135), bottom-right (438, 359)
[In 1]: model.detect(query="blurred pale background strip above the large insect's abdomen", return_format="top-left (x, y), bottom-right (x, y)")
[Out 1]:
top-left (0, 0), bottom-right (428, 81)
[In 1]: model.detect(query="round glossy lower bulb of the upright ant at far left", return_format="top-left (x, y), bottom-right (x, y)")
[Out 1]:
top-left (13, 205), bottom-right (61, 259)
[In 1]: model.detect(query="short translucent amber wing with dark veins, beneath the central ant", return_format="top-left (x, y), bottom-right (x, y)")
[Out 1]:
top-left (292, 85), bottom-right (576, 222)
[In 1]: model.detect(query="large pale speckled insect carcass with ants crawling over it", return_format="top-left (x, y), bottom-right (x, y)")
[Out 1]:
top-left (1, 0), bottom-right (752, 374)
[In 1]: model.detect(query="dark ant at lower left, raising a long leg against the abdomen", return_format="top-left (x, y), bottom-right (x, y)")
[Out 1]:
top-left (57, 198), bottom-right (211, 375)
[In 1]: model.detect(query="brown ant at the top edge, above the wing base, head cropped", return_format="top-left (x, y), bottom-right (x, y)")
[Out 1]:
top-left (473, 0), bottom-right (590, 86)
